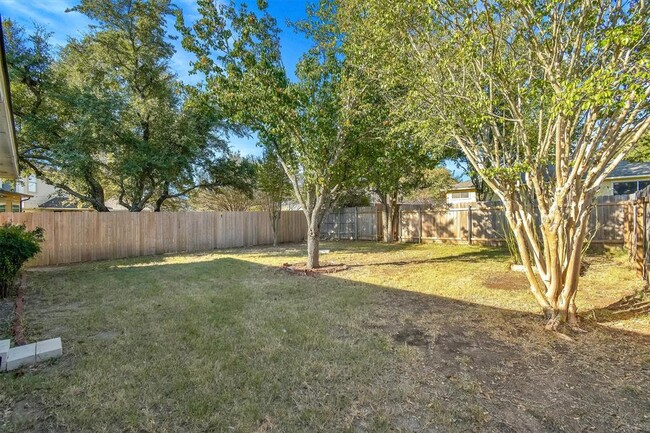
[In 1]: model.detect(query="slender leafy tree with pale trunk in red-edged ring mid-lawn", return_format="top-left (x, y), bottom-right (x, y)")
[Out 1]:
top-left (179, 0), bottom-right (359, 268)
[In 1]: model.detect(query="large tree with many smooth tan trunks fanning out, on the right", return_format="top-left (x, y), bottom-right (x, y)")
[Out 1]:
top-left (347, 0), bottom-right (650, 329)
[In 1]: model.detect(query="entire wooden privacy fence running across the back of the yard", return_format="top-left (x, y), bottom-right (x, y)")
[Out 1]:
top-left (0, 198), bottom-right (636, 270)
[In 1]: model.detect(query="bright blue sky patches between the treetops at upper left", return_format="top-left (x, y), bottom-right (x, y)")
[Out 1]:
top-left (0, 0), bottom-right (309, 155)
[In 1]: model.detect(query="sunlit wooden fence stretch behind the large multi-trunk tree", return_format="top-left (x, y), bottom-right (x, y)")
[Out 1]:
top-left (399, 201), bottom-right (629, 245)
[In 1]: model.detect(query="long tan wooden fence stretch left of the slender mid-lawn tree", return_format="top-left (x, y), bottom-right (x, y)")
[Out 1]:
top-left (0, 211), bottom-right (307, 266)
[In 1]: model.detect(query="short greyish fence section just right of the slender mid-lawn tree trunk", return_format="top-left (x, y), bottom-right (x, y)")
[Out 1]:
top-left (320, 206), bottom-right (381, 241)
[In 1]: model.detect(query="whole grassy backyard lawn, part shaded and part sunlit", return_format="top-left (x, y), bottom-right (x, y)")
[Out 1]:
top-left (0, 242), bottom-right (650, 432)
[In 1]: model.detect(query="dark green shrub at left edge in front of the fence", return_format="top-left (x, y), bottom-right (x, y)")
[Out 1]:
top-left (0, 223), bottom-right (43, 298)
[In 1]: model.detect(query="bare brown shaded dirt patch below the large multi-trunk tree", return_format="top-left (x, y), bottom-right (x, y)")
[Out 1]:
top-left (366, 284), bottom-right (650, 432)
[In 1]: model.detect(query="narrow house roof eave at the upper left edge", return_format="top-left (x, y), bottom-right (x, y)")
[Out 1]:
top-left (0, 17), bottom-right (18, 179)
